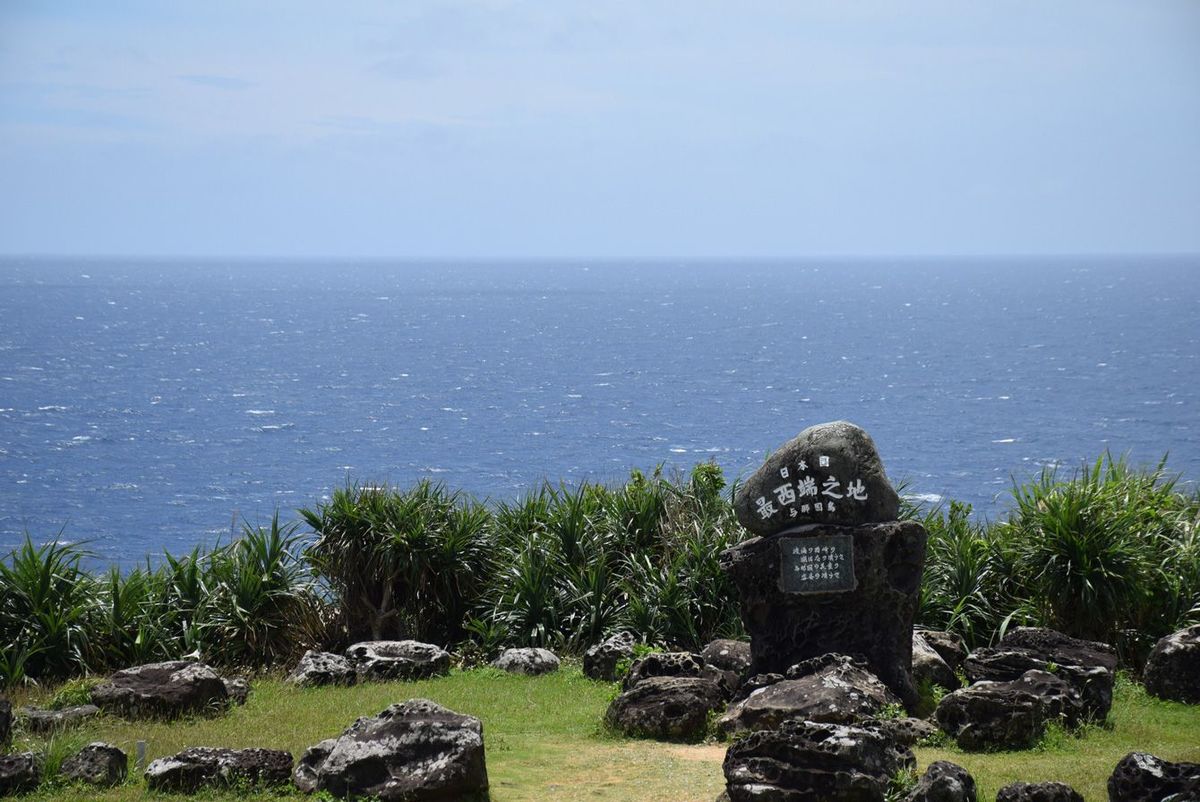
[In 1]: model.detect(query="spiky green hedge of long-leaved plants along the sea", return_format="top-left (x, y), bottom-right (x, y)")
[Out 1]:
top-left (0, 455), bottom-right (1200, 687)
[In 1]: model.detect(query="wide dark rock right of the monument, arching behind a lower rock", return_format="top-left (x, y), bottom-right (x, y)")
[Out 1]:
top-left (964, 627), bottom-right (1117, 722)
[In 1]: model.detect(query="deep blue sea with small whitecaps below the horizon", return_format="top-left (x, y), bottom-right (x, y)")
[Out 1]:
top-left (0, 257), bottom-right (1200, 565)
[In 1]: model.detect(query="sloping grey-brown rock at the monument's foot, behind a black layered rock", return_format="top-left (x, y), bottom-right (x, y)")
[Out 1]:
top-left (718, 654), bottom-right (900, 734)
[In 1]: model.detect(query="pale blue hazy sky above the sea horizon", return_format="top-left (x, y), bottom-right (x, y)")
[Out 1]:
top-left (0, 0), bottom-right (1200, 259)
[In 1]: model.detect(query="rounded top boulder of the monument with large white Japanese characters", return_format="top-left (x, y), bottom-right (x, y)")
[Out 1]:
top-left (733, 420), bottom-right (900, 537)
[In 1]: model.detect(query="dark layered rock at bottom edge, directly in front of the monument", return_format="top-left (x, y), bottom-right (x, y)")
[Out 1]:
top-left (724, 720), bottom-right (916, 802)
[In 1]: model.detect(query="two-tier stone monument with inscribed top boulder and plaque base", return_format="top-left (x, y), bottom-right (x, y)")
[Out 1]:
top-left (721, 420), bottom-right (925, 708)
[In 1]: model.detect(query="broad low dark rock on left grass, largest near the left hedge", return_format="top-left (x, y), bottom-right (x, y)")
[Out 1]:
top-left (91, 660), bottom-right (229, 718)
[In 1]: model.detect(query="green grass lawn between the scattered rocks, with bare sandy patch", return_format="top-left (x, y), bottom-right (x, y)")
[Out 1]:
top-left (9, 665), bottom-right (1200, 802)
